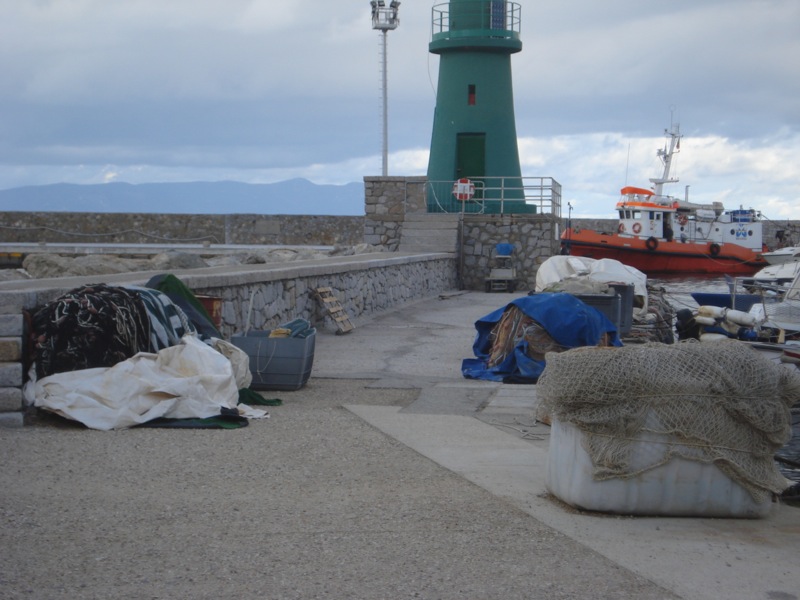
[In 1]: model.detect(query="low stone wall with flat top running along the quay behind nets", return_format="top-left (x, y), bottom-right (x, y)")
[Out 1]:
top-left (0, 252), bottom-right (458, 425)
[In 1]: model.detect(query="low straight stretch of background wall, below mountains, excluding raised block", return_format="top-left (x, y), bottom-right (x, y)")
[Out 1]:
top-left (0, 212), bottom-right (364, 246)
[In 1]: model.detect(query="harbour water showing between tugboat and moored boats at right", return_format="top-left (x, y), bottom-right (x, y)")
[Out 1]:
top-left (648, 275), bottom-right (800, 482)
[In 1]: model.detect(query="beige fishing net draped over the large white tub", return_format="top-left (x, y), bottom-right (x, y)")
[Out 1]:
top-left (537, 340), bottom-right (800, 502)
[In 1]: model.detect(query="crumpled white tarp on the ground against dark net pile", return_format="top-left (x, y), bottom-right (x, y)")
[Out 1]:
top-left (24, 334), bottom-right (267, 430)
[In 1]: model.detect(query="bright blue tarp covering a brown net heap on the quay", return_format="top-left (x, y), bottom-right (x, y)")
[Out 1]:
top-left (461, 292), bottom-right (622, 383)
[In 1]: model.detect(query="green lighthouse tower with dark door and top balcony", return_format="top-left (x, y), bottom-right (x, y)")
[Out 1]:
top-left (428, 0), bottom-right (535, 213)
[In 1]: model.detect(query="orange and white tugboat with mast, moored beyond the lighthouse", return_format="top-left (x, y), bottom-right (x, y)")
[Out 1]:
top-left (561, 125), bottom-right (767, 275)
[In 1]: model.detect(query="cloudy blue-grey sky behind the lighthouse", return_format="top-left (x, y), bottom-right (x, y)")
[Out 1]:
top-left (0, 0), bottom-right (800, 219)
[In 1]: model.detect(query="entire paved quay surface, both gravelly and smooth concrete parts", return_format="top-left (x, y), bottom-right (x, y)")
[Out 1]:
top-left (0, 293), bottom-right (800, 600)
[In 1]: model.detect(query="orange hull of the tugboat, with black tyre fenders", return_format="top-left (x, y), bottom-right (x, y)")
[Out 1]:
top-left (561, 229), bottom-right (768, 275)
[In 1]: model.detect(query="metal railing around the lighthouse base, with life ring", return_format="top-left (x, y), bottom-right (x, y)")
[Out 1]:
top-left (425, 175), bottom-right (561, 218)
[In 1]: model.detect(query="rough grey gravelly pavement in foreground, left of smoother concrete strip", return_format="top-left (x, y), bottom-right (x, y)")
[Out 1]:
top-left (0, 378), bottom-right (675, 600)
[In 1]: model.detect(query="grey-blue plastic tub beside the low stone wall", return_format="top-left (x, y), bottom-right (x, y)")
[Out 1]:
top-left (231, 329), bottom-right (317, 390)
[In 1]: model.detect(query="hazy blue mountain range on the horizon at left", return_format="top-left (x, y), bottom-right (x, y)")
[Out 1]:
top-left (0, 179), bottom-right (364, 216)
